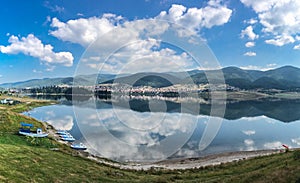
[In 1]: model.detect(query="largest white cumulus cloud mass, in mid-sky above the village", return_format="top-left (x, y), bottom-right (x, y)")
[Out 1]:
top-left (50, 0), bottom-right (232, 73)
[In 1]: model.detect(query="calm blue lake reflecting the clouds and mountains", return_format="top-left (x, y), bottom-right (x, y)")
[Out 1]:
top-left (25, 97), bottom-right (300, 162)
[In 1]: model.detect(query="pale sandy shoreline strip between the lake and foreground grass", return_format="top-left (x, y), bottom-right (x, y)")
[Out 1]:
top-left (82, 149), bottom-right (286, 171)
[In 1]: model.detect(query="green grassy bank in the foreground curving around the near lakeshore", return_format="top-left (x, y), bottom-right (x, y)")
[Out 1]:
top-left (0, 95), bottom-right (300, 182)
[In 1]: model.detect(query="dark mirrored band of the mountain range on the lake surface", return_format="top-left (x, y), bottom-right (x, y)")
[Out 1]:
top-left (28, 96), bottom-right (300, 122)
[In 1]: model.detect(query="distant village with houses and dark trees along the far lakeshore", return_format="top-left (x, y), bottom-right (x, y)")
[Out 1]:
top-left (1, 83), bottom-right (240, 97)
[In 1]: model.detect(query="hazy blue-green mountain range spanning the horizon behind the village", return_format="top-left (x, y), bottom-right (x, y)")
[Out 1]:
top-left (0, 66), bottom-right (300, 90)
